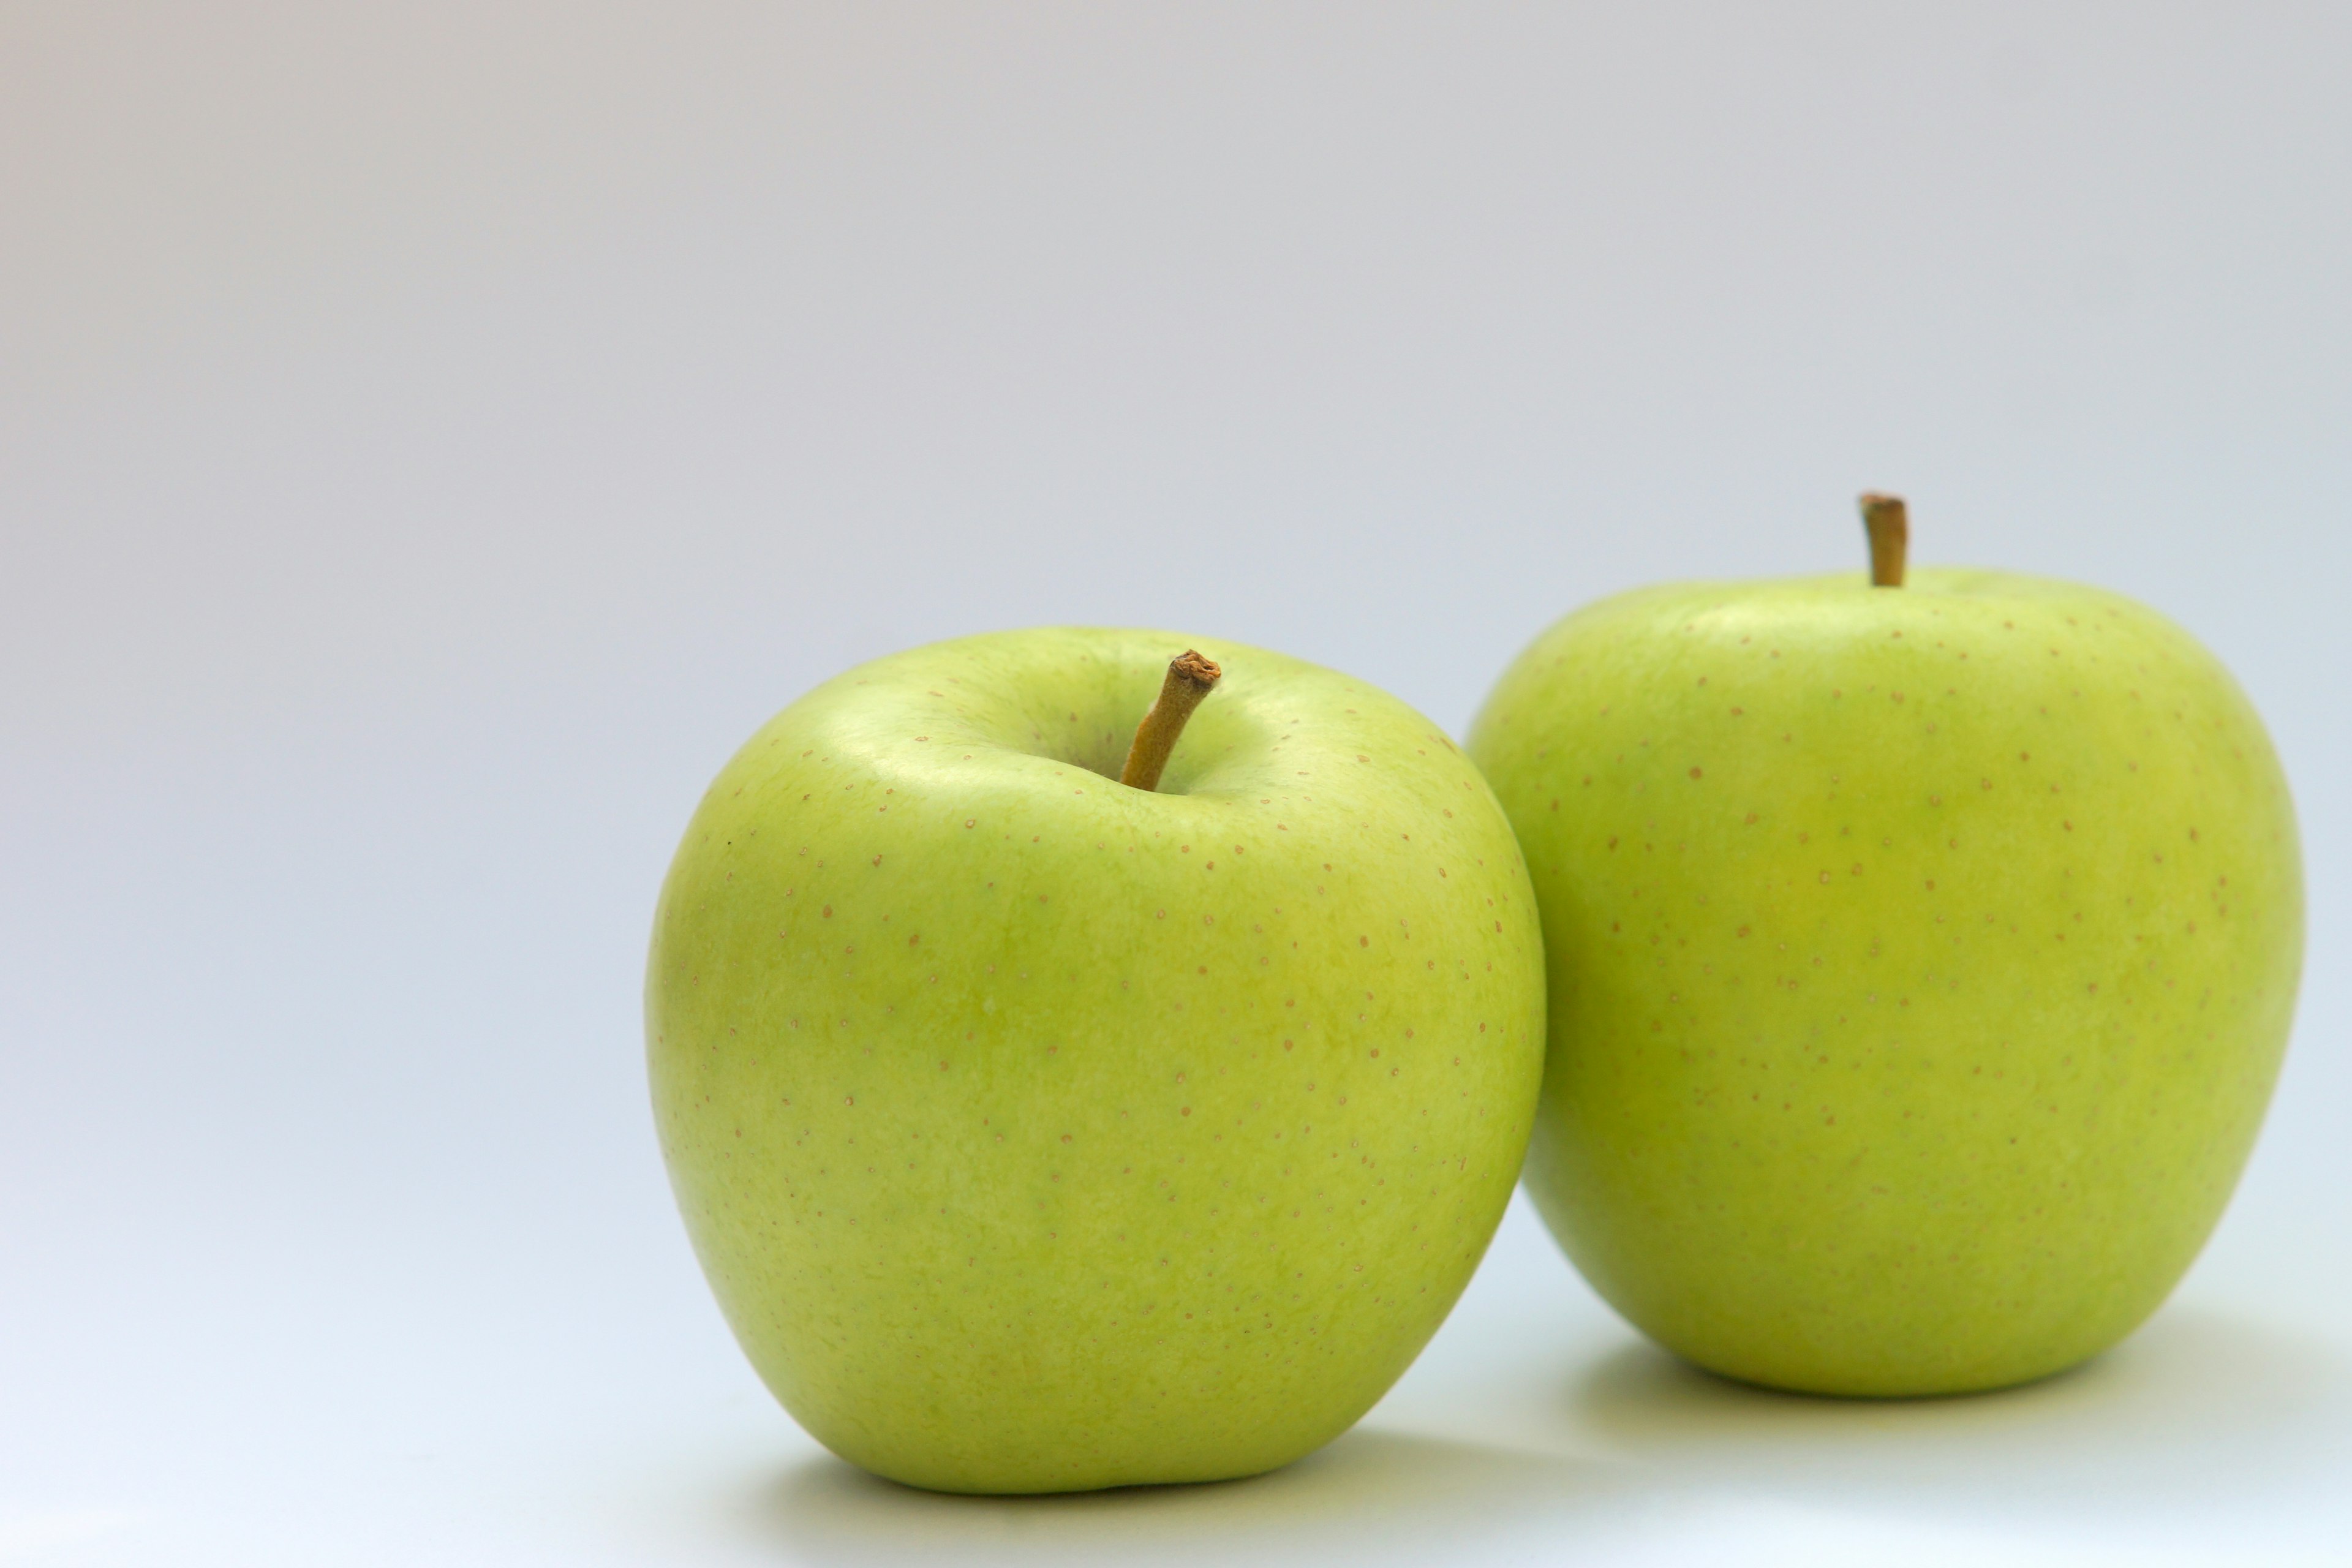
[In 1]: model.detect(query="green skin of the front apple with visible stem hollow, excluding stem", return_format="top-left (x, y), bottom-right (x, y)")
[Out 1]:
top-left (647, 630), bottom-right (1543, 1493)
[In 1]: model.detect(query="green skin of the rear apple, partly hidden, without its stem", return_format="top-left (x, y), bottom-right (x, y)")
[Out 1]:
top-left (1470, 571), bottom-right (2302, 1396)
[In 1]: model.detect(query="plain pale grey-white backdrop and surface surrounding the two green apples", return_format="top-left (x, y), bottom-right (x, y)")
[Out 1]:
top-left (0, 0), bottom-right (2352, 1568)
